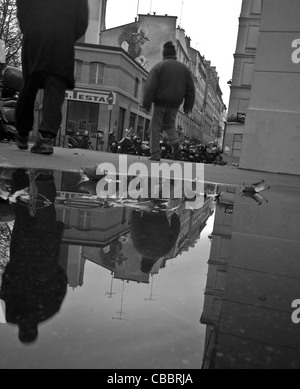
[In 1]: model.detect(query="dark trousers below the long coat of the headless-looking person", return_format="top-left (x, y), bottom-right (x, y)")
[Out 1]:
top-left (16, 74), bottom-right (67, 138)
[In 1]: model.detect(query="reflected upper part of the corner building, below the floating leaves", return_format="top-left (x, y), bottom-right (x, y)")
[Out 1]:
top-left (56, 204), bottom-right (130, 287)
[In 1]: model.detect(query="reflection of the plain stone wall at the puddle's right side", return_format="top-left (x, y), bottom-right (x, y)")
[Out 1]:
top-left (201, 183), bottom-right (300, 369)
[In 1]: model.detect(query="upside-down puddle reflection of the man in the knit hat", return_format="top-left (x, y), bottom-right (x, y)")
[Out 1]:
top-left (131, 211), bottom-right (180, 273)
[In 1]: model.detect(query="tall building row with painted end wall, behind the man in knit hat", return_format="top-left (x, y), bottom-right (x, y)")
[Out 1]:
top-left (100, 13), bottom-right (225, 142)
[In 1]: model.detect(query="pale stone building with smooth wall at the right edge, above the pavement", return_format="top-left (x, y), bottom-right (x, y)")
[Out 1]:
top-left (223, 0), bottom-right (300, 174)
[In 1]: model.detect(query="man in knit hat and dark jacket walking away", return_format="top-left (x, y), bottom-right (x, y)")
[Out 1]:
top-left (143, 42), bottom-right (195, 161)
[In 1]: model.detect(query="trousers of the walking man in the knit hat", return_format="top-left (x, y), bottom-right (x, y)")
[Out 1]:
top-left (150, 105), bottom-right (181, 158)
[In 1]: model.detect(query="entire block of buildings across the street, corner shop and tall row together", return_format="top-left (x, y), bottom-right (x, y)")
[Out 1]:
top-left (33, 0), bottom-right (225, 146)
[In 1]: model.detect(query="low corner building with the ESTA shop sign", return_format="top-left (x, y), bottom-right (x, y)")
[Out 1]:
top-left (35, 43), bottom-right (151, 151)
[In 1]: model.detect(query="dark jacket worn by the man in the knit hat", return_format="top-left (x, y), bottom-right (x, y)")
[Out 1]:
top-left (143, 57), bottom-right (195, 111)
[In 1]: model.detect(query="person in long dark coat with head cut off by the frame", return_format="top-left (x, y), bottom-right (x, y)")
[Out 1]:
top-left (16, 0), bottom-right (89, 155)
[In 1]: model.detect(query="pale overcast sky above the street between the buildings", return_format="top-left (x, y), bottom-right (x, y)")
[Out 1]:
top-left (106, 0), bottom-right (242, 107)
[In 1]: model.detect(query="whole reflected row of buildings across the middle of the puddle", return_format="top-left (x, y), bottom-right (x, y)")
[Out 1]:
top-left (56, 173), bottom-right (214, 288)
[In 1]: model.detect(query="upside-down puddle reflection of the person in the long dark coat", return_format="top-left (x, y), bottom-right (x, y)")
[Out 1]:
top-left (0, 170), bottom-right (68, 344)
